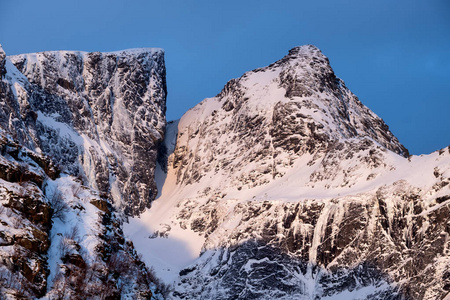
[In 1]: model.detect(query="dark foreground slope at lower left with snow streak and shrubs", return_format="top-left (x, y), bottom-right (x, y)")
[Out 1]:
top-left (0, 129), bottom-right (164, 299)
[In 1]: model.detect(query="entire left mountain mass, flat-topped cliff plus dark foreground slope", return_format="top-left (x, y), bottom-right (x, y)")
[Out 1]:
top-left (0, 48), bottom-right (166, 299)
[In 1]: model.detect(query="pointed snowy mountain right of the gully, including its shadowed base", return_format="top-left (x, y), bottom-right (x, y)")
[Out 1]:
top-left (124, 46), bottom-right (450, 299)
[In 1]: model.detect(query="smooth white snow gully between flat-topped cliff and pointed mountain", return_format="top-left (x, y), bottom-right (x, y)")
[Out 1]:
top-left (124, 122), bottom-right (204, 284)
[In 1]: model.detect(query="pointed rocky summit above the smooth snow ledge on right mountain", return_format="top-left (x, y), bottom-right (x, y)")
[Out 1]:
top-left (174, 45), bottom-right (408, 192)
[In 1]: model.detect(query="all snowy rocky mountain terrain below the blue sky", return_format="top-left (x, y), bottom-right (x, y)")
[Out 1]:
top-left (0, 45), bottom-right (450, 300)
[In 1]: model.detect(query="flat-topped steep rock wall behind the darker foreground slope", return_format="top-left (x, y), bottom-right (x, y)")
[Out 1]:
top-left (0, 49), bottom-right (166, 215)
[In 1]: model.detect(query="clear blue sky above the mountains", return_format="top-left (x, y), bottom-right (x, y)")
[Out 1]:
top-left (0, 0), bottom-right (450, 154)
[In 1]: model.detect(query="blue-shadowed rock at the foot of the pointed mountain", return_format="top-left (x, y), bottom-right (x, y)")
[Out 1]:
top-left (173, 240), bottom-right (404, 300)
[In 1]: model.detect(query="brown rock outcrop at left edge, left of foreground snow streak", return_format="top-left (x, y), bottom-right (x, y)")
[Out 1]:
top-left (0, 132), bottom-right (56, 297)
